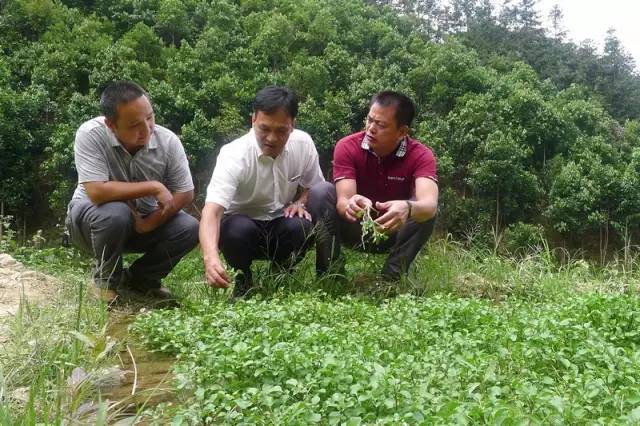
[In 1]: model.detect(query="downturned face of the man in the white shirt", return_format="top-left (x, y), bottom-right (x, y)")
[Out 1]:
top-left (251, 108), bottom-right (295, 158)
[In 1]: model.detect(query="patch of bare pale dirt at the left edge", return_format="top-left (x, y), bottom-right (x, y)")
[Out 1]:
top-left (0, 253), bottom-right (62, 343)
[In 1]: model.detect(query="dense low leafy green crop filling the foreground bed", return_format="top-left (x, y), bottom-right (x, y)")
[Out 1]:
top-left (133, 294), bottom-right (640, 425)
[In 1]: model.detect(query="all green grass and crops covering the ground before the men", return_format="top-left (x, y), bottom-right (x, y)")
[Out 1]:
top-left (0, 240), bottom-right (640, 425)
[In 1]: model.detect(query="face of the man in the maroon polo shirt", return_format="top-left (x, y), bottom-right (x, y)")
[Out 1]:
top-left (365, 103), bottom-right (409, 157)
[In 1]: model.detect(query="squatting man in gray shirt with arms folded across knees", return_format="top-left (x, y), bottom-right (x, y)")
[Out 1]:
top-left (67, 81), bottom-right (198, 303)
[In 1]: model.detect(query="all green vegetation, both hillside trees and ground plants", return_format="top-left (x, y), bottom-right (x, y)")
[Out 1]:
top-left (0, 0), bottom-right (640, 424)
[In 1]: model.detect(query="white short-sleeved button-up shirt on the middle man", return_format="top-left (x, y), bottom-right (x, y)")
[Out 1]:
top-left (206, 129), bottom-right (324, 220)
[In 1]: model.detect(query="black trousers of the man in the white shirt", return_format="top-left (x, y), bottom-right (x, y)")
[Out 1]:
top-left (219, 214), bottom-right (313, 276)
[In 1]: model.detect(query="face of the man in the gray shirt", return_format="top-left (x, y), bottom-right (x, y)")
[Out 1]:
top-left (105, 96), bottom-right (156, 154)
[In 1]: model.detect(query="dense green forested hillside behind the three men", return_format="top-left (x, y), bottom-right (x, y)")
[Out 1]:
top-left (0, 0), bottom-right (640, 258)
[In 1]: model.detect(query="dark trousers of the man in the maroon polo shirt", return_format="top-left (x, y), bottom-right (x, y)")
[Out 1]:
top-left (307, 182), bottom-right (435, 280)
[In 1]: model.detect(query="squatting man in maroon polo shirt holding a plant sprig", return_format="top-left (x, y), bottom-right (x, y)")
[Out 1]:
top-left (308, 91), bottom-right (438, 280)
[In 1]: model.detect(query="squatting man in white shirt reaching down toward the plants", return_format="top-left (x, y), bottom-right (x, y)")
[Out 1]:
top-left (200, 86), bottom-right (324, 298)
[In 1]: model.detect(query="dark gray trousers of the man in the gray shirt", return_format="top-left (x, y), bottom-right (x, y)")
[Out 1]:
top-left (67, 199), bottom-right (199, 289)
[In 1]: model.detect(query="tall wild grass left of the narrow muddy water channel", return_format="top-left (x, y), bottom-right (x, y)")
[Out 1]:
top-left (0, 247), bottom-right (113, 425)
